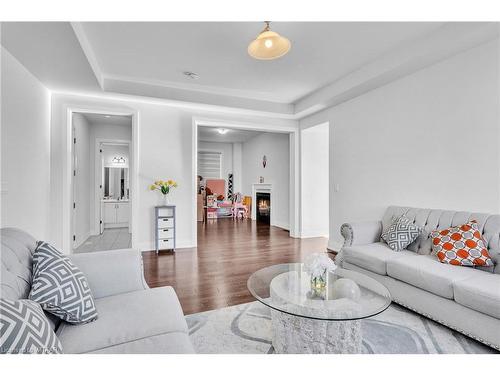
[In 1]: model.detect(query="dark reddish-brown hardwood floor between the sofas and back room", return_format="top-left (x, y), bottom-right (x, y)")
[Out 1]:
top-left (143, 219), bottom-right (328, 314)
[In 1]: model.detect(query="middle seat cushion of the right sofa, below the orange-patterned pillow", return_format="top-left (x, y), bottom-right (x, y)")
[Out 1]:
top-left (387, 255), bottom-right (476, 299)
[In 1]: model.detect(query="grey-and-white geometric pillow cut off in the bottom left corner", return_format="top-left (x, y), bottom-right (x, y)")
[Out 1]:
top-left (0, 298), bottom-right (62, 354)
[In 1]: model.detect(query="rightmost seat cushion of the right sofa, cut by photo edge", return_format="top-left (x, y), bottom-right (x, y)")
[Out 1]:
top-left (453, 272), bottom-right (500, 319)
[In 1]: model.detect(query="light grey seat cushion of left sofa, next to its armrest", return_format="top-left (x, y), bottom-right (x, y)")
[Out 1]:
top-left (57, 287), bottom-right (188, 353)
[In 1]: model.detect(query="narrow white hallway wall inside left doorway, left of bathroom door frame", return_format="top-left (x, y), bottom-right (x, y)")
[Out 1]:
top-left (73, 113), bottom-right (93, 248)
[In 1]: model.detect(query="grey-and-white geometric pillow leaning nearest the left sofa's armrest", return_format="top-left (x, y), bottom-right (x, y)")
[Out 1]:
top-left (29, 241), bottom-right (97, 324)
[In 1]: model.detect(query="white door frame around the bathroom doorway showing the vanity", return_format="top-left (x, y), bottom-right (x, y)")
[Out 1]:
top-left (93, 138), bottom-right (132, 235)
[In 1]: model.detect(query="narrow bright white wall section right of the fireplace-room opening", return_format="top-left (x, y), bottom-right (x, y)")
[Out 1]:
top-left (301, 123), bottom-right (330, 237)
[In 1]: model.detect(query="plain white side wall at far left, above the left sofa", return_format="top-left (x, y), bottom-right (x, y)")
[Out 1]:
top-left (1, 47), bottom-right (50, 240)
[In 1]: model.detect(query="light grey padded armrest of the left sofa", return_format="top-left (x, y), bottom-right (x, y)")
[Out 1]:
top-left (70, 249), bottom-right (148, 298)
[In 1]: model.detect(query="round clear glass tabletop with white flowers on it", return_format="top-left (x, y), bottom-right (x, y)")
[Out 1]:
top-left (247, 263), bottom-right (391, 321)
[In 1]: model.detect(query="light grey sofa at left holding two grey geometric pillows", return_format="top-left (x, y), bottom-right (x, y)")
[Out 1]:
top-left (0, 228), bottom-right (194, 354)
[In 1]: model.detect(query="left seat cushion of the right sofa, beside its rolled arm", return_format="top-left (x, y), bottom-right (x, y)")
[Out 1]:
top-left (342, 242), bottom-right (417, 275)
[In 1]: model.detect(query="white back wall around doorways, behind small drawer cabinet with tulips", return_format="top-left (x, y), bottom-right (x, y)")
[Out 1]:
top-left (47, 94), bottom-right (297, 252)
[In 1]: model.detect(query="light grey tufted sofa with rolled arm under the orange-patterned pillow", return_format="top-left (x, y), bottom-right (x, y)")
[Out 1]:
top-left (336, 206), bottom-right (500, 350)
